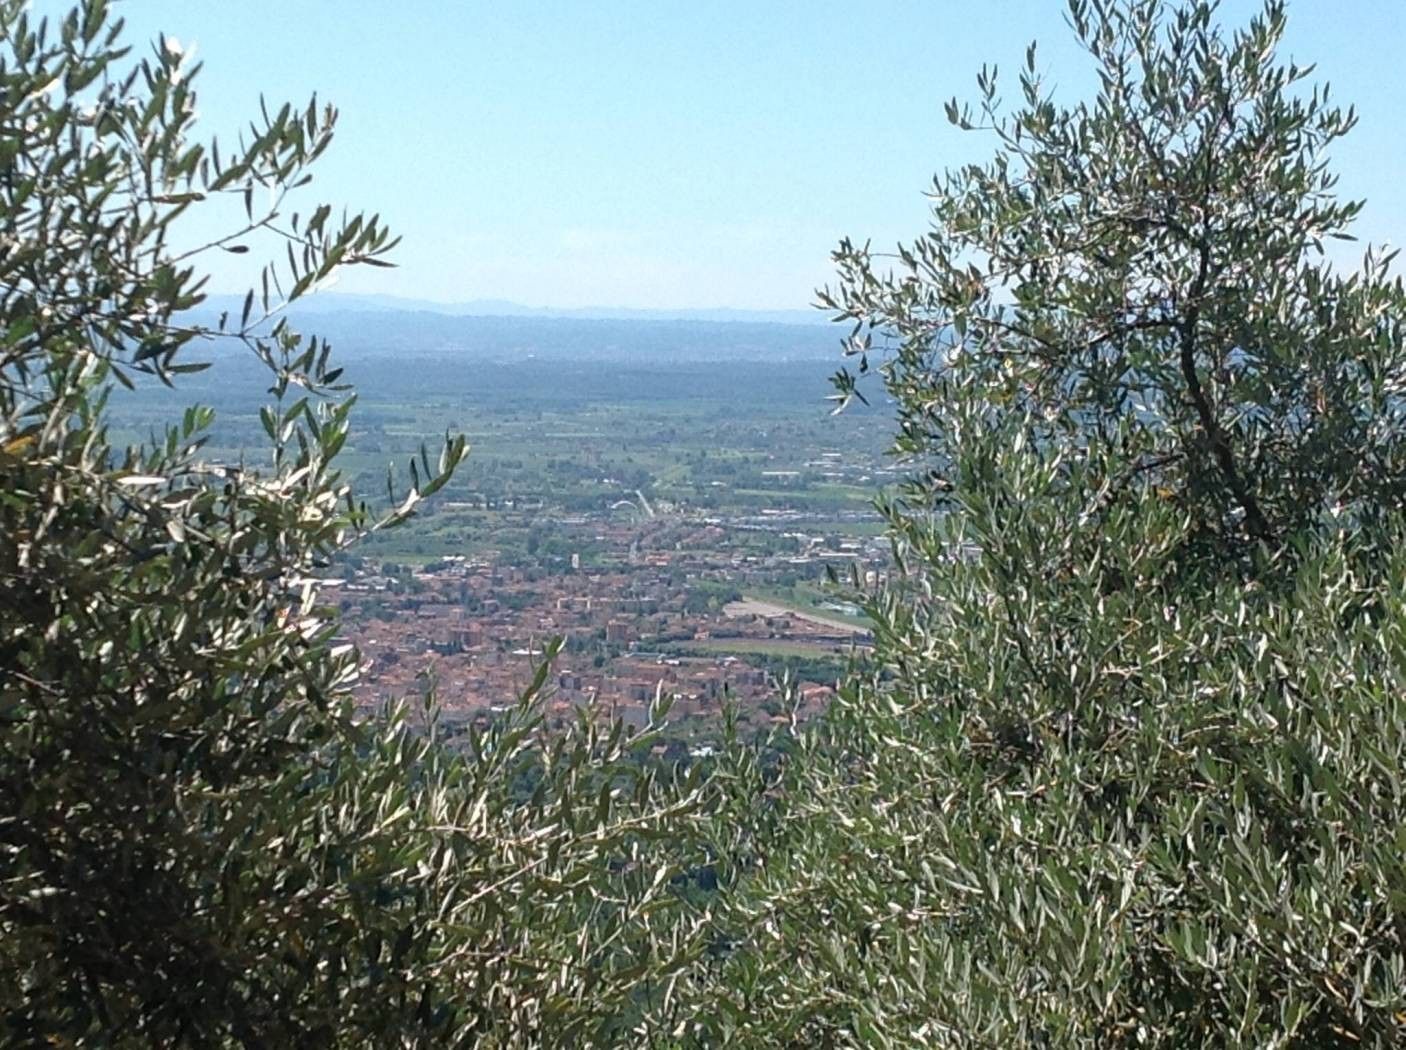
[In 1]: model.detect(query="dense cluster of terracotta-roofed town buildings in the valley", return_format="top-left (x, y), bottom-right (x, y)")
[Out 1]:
top-left (333, 550), bottom-right (863, 725)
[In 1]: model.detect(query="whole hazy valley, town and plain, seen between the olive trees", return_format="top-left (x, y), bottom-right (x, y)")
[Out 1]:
top-left (106, 330), bottom-right (910, 746)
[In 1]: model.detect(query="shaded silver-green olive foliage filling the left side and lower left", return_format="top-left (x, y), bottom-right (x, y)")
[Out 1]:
top-left (0, 0), bottom-right (714, 1047)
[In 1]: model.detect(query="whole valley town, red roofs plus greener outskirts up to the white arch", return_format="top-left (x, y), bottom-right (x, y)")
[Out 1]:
top-left (323, 500), bottom-right (886, 746)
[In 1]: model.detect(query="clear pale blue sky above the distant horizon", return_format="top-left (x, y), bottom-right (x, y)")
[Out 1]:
top-left (82, 0), bottom-right (1406, 309)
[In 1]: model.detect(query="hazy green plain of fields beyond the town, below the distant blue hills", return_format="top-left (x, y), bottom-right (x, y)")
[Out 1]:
top-left (115, 357), bottom-right (890, 579)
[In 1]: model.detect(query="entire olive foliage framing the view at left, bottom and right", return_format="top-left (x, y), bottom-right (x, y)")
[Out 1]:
top-left (0, 0), bottom-right (1406, 1047)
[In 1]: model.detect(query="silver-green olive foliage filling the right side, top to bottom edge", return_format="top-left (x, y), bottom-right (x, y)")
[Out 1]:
top-left (683, 0), bottom-right (1406, 1047)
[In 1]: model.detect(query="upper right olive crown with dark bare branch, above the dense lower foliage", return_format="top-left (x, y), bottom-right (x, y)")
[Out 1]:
top-left (827, 3), bottom-right (1403, 559)
